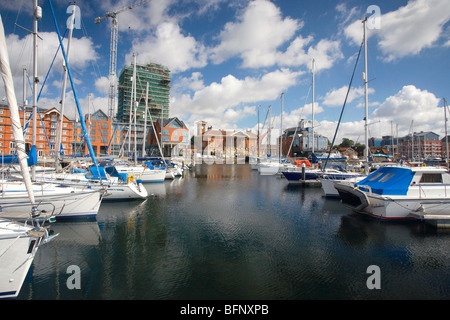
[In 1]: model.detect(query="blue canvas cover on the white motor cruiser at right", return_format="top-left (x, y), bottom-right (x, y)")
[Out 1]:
top-left (355, 167), bottom-right (414, 195)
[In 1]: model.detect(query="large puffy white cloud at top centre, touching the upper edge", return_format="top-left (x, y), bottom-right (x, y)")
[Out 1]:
top-left (211, 0), bottom-right (342, 70)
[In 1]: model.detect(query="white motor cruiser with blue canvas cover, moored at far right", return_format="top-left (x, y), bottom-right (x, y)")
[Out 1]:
top-left (335, 167), bottom-right (450, 220)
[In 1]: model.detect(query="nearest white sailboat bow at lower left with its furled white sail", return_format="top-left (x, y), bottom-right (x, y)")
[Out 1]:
top-left (0, 11), bottom-right (54, 298)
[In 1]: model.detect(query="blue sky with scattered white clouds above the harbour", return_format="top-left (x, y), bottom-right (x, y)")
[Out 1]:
top-left (0, 0), bottom-right (450, 143)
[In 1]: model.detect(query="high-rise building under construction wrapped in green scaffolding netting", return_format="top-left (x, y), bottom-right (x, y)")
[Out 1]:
top-left (116, 63), bottom-right (170, 123)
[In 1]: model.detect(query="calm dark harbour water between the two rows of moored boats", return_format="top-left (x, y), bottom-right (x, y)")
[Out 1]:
top-left (19, 164), bottom-right (450, 300)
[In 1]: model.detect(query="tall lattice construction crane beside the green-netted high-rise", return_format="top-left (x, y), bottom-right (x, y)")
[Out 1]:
top-left (95, 0), bottom-right (151, 120)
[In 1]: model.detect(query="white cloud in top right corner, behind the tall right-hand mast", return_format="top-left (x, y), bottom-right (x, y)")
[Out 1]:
top-left (344, 0), bottom-right (450, 61)
